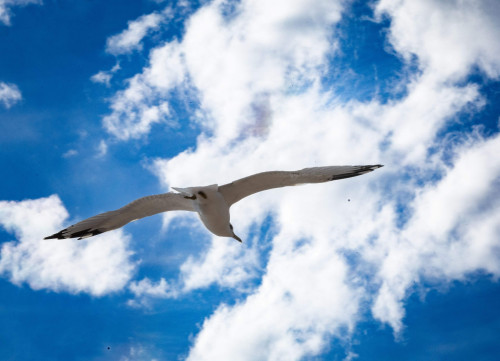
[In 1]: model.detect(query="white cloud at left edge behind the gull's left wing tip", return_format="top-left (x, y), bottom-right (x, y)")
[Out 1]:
top-left (0, 195), bottom-right (135, 296)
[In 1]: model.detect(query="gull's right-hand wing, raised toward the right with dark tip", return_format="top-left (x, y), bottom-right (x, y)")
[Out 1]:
top-left (219, 164), bottom-right (383, 206)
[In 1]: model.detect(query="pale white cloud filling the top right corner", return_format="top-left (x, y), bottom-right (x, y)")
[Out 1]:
top-left (376, 0), bottom-right (500, 80)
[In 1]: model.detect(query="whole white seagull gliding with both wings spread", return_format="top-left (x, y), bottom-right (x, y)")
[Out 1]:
top-left (44, 164), bottom-right (383, 242)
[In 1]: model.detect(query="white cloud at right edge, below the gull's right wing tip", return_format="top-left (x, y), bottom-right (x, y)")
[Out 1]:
top-left (373, 136), bottom-right (500, 331)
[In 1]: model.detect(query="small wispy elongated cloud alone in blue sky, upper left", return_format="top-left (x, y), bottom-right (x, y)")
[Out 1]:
top-left (106, 8), bottom-right (172, 55)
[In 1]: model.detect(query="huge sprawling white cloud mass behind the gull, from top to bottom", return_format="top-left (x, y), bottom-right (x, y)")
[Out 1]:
top-left (100, 0), bottom-right (500, 360)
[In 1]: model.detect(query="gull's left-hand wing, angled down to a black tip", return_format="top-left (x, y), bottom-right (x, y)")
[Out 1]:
top-left (45, 193), bottom-right (195, 239)
